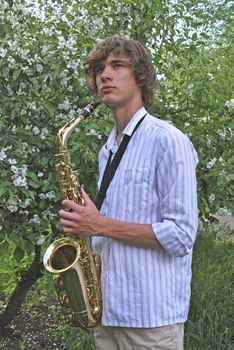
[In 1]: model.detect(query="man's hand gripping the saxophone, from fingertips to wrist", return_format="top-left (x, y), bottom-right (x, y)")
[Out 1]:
top-left (59, 189), bottom-right (103, 237)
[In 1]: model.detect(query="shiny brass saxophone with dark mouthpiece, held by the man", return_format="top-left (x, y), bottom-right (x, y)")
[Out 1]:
top-left (43, 103), bottom-right (102, 330)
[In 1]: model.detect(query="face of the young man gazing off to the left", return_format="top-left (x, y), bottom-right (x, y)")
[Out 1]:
top-left (96, 54), bottom-right (141, 108)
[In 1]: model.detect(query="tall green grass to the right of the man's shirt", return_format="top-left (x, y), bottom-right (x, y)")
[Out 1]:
top-left (185, 226), bottom-right (234, 350)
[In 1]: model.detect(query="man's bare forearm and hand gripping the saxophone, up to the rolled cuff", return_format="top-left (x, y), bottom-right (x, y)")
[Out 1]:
top-left (59, 189), bottom-right (163, 250)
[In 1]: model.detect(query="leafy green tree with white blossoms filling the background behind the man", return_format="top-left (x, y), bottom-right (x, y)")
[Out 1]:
top-left (0, 0), bottom-right (234, 334)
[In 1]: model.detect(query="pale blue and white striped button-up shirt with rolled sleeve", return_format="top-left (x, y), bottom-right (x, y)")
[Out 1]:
top-left (92, 107), bottom-right (198, 328)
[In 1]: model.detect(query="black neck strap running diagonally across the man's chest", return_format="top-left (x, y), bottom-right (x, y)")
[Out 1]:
top-left (95, 114), bottom-right (146, 210)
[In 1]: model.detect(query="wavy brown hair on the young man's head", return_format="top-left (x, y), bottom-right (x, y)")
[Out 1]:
top-left (84, 35), bottom-right (156, 107)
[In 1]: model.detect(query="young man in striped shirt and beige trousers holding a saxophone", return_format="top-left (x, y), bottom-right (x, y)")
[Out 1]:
top-left (59, 36), bottom-right (197, 350)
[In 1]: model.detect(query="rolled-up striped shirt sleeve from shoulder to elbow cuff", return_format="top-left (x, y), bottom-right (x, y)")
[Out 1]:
top-left (152, 132), bottom-right (198, 256)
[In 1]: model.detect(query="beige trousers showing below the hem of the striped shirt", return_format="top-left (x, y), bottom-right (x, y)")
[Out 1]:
top-left (94, 323), bottom-right (184, 350)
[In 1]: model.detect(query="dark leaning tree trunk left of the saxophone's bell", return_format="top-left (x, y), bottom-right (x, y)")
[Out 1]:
top-left (0, 245), bottom-right (43, 337)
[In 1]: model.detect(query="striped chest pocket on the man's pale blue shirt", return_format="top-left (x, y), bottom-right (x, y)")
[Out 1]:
top-left (121, 167), bottom-right (150, 214)
